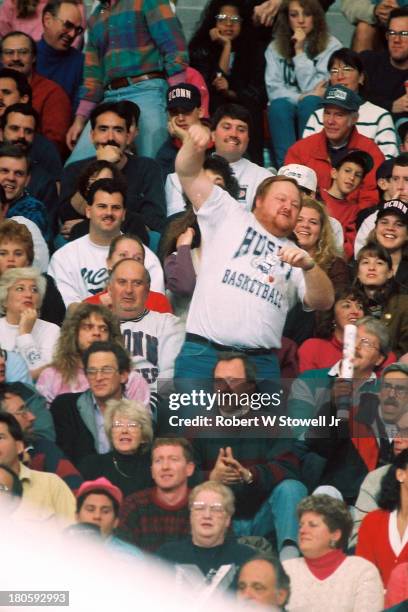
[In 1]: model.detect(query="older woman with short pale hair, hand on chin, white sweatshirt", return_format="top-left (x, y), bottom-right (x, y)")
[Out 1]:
top-left (0, 268), bottom-right (60, 380)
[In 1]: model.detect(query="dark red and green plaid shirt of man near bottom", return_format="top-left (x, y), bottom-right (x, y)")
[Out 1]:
top-left (116, 488), bottom-right (190, 552)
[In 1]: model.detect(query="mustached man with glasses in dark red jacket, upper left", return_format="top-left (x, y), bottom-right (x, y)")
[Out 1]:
top-left (1, 31), bottom-right (72, 155)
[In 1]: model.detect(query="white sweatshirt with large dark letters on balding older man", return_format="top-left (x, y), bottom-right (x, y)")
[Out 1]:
top-left (120, 310), bottom-right (184, 391)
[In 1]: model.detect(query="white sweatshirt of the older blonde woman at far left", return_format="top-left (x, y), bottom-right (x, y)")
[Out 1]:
top-left (0, 317), bottom-right (60, 370)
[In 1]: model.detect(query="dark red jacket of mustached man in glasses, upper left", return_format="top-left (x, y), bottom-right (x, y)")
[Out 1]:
top-left (30, 71), bottom-right (72, 157)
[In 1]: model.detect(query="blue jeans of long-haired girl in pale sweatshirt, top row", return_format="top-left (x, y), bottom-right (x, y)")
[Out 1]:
top-left (268, 96), bottom-right (322, 168)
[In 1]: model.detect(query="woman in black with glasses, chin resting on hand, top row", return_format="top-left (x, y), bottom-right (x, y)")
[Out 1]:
top-left (189, 0), bottom-right (266, 165)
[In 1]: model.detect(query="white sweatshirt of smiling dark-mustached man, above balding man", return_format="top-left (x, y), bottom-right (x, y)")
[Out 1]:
top-left (48, 234), bottom-right (164, 306)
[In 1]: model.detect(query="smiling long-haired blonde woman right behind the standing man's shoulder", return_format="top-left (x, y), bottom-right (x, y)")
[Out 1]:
top-left (284, 196), bottom-right (349, 344)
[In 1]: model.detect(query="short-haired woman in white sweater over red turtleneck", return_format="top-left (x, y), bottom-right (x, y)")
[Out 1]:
top-left (283, 495), bottom-right (384, 612)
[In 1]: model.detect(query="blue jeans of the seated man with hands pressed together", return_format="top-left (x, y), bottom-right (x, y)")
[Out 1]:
top-left (232, 479), bottom-right (307, 552)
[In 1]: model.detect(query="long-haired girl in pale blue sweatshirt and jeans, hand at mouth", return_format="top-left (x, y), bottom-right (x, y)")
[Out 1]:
top-left (265, 0), bottom-right (342, 167)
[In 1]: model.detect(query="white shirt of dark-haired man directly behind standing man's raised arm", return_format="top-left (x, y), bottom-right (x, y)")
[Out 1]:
top-left (165, 157), bottom-right (272, 217)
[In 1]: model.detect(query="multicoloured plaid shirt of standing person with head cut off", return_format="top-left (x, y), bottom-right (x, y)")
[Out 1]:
top-left (80, 0), bottom-right (188, 104)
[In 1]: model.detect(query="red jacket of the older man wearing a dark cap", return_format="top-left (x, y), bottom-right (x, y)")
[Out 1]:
top-left (284, 127), bottom-right (385, 209)
